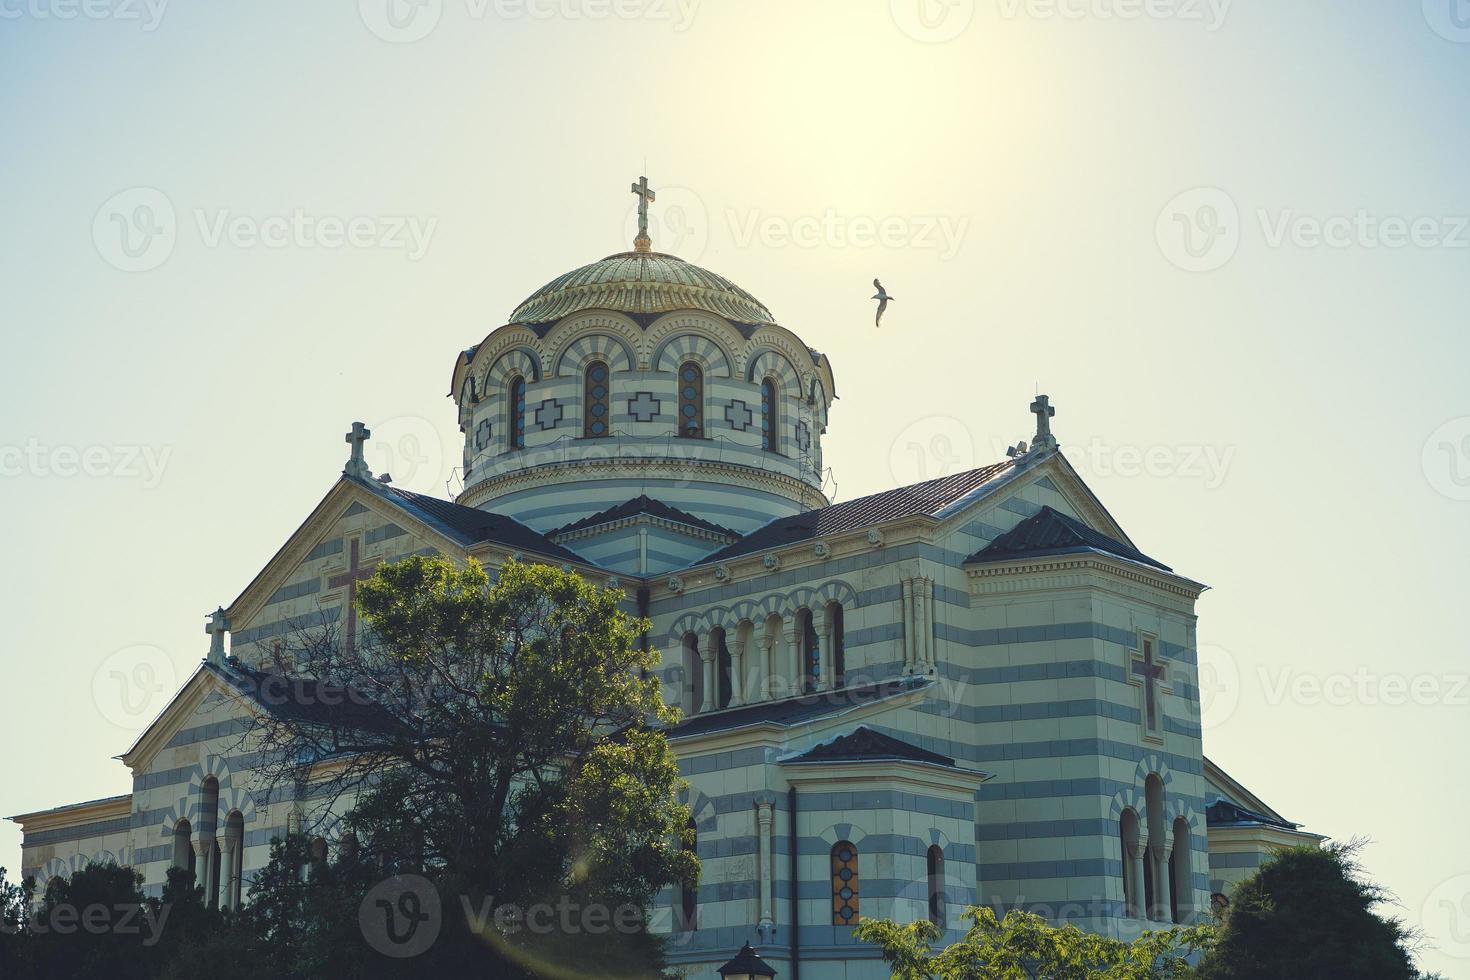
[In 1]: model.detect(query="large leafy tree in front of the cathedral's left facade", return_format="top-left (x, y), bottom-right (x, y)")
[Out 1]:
top-left (243, 557), bottom-right (698, 977)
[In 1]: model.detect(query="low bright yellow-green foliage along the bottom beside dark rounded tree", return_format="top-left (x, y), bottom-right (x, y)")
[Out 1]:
top-left (853, 907), bottom-right (1213, 980)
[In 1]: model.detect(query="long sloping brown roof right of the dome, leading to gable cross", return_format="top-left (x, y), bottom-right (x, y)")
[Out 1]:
top-left (700, 460), bottom-right (1016, 564)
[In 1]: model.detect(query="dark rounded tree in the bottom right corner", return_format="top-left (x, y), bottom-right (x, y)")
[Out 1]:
top-left (1200, 840), bottom-right (1420, 980)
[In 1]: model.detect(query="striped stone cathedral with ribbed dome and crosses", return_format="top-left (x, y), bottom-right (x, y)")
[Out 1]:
top-left (13, 181), bottom-right (1320, 980)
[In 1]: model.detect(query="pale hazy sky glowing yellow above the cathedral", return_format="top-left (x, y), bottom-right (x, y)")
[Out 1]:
top-left (0, 0), bottom-right (1470, 977)
